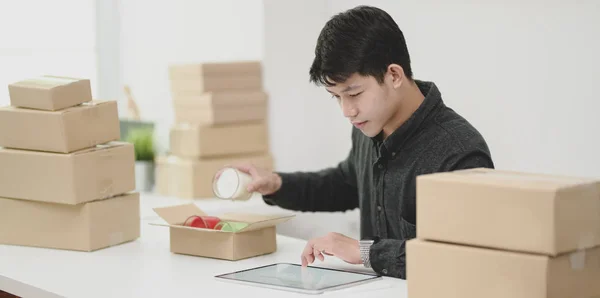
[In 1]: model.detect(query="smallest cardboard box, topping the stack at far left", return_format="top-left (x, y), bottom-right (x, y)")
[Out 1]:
top-left (8, 76), bottom-right (92, 111)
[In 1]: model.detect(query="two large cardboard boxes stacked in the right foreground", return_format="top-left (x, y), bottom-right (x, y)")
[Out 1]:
top-left (406, 169), bottom-right (600, 298)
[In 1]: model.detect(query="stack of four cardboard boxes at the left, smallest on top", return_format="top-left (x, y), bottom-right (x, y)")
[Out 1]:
top-left (0, 76), bottom-right (140, 251)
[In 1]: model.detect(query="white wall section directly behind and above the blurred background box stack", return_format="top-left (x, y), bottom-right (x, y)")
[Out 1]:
top-left (119, 0), bottom-right (263, 152)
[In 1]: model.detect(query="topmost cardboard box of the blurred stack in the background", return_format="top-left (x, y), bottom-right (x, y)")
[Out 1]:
top-left (169, 61), bottom-right (263, 96)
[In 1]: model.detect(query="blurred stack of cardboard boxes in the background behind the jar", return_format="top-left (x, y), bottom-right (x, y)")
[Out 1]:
top-left (156, 61), bottom-right (273, 199)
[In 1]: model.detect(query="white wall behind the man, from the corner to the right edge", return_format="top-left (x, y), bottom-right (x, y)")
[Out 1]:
top-left (265, 0), bottom-right (600, 177)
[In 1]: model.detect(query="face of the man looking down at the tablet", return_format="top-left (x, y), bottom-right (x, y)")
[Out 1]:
top-left (326, 74), bottom-right (398, 137)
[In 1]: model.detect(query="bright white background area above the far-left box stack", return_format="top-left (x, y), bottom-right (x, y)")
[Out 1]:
top-left (0, 0), bottom-right (98, 106)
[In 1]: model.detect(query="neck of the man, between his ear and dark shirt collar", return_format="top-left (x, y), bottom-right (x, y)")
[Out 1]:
top-left (383, 81), bottom-right (425, 140)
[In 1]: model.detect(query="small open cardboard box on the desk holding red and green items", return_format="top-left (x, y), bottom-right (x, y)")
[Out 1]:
top-left (154, 204), bottom-right (294, 261)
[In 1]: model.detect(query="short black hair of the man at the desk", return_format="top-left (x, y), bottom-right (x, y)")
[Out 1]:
top-left (309, 6), bottom-right (413, 86)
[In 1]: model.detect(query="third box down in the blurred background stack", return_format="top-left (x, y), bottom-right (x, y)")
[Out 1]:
top-left (169, 122), bottom-right (269, 158)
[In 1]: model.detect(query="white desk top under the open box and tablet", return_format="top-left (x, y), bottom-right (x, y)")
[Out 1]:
top-left (0, 195), bottom-right (407, 297)
